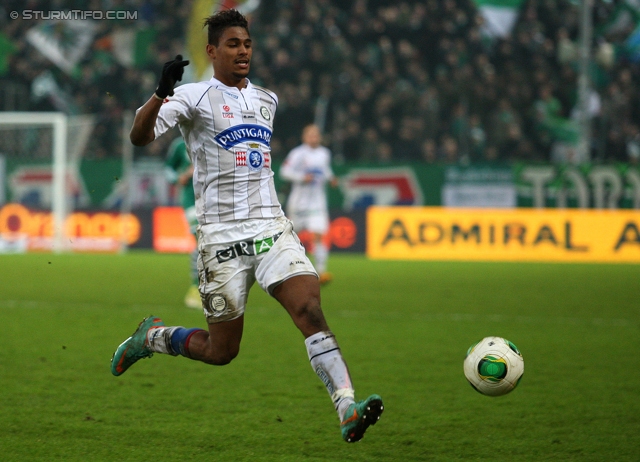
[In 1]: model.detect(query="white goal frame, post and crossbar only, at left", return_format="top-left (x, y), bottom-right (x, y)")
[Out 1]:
top-left (0, 112), bottom-right (68, 253)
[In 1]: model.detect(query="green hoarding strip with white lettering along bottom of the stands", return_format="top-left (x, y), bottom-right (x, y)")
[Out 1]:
top-left (0, 159), bottom-right (640, 211)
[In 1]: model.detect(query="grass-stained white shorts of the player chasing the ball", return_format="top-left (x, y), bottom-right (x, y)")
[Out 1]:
top-left (198, 218), bottom-right (318, 324)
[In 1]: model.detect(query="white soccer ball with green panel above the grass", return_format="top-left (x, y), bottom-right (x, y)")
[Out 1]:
top-left (464, 337), bottom-right (524, 396)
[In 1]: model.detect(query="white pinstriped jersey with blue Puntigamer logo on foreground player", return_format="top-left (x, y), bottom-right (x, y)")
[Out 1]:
top-left (149, 77), bottom-right (284, 225)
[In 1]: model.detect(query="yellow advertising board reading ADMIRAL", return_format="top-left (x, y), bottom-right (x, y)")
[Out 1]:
top-left (367, 207), bottom-right (640, 263)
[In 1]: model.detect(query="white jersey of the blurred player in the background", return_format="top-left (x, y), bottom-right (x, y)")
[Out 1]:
top-left (280, 144), bottom-right (334, 215)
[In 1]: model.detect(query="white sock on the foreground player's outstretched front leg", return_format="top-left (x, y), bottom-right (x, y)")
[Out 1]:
top-left (304, 331), bottom-right (355, 421)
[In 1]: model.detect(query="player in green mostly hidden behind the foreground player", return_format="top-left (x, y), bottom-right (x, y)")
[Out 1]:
top-left (164, 137), bottom-right (202, 308)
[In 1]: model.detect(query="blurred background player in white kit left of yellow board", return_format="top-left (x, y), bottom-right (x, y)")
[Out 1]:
top-left (280, 124), bottom-right (337, 284)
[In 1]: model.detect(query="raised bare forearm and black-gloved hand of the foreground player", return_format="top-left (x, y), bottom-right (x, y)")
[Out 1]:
top-left (129, 55), bottom-right (189, 146)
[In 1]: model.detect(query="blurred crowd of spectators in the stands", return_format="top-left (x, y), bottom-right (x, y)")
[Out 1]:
top-left (0, 0), bottom-right (640, 164)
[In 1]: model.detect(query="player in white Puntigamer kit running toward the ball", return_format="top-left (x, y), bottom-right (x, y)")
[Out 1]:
top-left (111, 10), bottom-right (384, 442)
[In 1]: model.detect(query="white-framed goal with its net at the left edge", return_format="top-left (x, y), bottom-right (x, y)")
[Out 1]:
top-left (0, 112), bottom-right (100, 252)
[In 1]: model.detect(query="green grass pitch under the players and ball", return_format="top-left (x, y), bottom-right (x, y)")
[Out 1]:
top-left (0, 252), bottom-right (640, 462)
